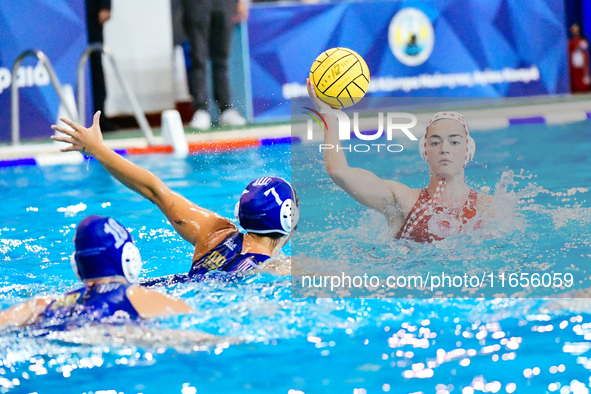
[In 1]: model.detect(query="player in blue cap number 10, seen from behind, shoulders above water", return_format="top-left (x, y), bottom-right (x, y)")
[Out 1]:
top-left (0, 215), bottom-right (193, 328)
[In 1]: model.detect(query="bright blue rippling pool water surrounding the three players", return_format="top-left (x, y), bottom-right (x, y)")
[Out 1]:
top-left (0, 122), bottom-right (591, 394)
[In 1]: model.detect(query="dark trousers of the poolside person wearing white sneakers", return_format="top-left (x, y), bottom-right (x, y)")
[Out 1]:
top-left (181, 0), bottom-right (237, 111)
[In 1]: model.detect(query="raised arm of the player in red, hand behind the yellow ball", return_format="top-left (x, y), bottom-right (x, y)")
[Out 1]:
top-left (308, 80), bottom-right (408, 213)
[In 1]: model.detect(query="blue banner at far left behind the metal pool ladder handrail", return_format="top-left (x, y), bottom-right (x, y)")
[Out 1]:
top-left (0, 0), bottom-right (89, 142)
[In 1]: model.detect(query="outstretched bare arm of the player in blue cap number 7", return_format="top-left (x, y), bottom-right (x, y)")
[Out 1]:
top-left (51, 111), bottom-right (236, 247)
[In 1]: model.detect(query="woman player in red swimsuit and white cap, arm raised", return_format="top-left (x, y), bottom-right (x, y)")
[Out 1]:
top-left (308, 80), bottom-right (492, 242)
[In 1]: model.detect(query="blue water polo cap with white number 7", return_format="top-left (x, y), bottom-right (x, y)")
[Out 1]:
top-left (234, 177), bottom-right (299, 235)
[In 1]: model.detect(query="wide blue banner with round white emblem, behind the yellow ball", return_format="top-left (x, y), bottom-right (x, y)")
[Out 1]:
top-left (248, 0), bottom-right (569, 121)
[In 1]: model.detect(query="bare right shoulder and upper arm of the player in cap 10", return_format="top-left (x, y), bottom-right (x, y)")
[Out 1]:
top-left (127, 286), bottom-right (193, 319)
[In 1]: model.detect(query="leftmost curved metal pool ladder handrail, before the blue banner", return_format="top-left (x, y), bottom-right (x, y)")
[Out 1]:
top-left (10, 49), bottom-right (76, 145)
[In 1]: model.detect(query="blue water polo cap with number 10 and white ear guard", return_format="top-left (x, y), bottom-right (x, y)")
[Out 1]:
top-left (72, 215), bottom-right (142, 283)
